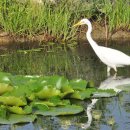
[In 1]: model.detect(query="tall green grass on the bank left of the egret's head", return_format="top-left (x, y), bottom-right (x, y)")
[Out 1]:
top-left (0, 0), bottom-right (93, 41)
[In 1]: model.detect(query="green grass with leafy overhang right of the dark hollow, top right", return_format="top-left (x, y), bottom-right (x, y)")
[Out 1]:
top-left (96, 0), bottom-right (130, 32)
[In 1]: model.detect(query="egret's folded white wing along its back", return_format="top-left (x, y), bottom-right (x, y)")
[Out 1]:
top-left (99, 46), bottom-right (130, 65)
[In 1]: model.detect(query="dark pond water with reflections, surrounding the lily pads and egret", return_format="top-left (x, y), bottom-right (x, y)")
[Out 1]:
top-left (0, 41), bottom-right (130, 130)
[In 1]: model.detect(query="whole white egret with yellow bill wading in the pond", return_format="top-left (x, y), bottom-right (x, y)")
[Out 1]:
top-left (74, 19), bottom-right (130, 73)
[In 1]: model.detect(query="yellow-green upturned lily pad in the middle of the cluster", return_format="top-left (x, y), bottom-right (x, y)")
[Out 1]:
top-left (35, 86), bottom-right (61, 99)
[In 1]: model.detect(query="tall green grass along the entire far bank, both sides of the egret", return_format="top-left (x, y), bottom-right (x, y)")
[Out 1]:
top-left (0, 0), bottom-right (130, 42)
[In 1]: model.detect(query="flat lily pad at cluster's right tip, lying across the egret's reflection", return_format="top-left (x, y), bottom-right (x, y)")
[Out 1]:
top-left (92, 89), bottom-right (117, 98)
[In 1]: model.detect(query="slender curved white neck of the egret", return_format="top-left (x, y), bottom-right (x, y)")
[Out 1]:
top-left (86, 22), bottom-right (98, 50)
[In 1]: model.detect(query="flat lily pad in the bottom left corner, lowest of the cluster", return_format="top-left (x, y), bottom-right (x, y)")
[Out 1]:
top-left (0, 114), bottom-right (37, 124)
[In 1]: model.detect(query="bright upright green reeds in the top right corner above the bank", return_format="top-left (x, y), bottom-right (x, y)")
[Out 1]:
top-left (108, 0), bottom-right (130, 31)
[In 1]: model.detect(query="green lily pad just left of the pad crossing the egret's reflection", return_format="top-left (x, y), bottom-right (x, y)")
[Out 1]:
top-left (70, 88), bottom-right (96, 100)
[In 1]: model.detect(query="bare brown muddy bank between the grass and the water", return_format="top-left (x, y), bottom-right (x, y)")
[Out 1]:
top-left (0, 23), bottom-right (130, 45)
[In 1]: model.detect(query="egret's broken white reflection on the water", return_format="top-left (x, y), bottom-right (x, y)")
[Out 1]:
top-left (81, 75), bottom-right (130, 129)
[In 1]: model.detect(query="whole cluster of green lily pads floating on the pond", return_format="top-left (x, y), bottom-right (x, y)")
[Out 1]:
top-left (0, 72), bottom-right (116, 124)
